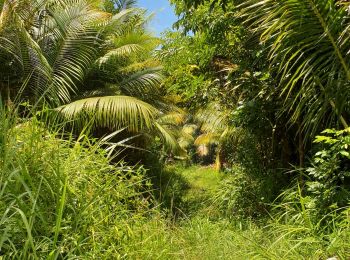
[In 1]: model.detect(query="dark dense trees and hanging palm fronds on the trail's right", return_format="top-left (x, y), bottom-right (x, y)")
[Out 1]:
top-left (162, 0), bottom-right (349, 203)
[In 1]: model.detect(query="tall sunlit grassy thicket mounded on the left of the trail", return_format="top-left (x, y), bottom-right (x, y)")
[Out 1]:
top-left (0, 110), bottom-right (155, 259)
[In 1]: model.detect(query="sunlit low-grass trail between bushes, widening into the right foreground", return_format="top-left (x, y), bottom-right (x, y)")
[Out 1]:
top-left (145, 165), bottom-right (347, 260)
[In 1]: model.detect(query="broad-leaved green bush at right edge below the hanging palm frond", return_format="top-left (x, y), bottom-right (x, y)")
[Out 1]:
top-left (306, 129), bottom-right (350, 216)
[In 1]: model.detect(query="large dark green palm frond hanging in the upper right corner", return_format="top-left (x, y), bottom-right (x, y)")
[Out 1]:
top-left (241, 0), bottom-right (350, 134)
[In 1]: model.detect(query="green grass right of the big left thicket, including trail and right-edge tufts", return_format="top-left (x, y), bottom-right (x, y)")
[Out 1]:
top-left (154, 166), bottom-right (350, 260)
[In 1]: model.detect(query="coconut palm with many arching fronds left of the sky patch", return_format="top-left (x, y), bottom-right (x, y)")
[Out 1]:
top-left (0, 0), bottom-right (180, 152)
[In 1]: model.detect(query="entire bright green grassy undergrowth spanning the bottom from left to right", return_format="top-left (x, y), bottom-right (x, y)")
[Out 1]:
top-left (0, 107), bottom-right (350, 260)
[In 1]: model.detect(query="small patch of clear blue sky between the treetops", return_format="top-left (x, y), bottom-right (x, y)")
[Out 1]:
top-left (138, 0), bottom-right (177, 35)
